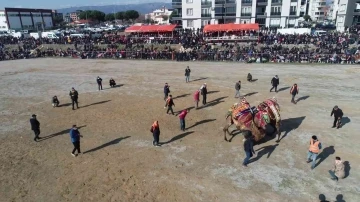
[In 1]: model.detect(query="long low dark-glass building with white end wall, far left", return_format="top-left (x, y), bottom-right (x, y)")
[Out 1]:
top-left (0, 8), bottom-right (54, 30)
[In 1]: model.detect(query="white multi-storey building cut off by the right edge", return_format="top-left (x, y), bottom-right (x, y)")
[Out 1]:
top-left (333, 0), bottom-right (360, 31)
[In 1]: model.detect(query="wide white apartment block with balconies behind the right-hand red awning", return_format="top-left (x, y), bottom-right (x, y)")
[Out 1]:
top-left (172, 0), bottom-right (311, 29)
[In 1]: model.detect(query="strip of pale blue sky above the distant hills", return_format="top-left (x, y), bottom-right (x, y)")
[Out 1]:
top-left (0, 0), bottom-right (171, 9)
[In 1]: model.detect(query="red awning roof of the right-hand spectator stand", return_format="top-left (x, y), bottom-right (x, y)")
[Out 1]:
top-left (204, 23), bottom-right (259, 32)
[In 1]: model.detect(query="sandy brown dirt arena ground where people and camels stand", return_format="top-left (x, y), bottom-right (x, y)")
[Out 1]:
top-left (0, 59), bottom-right (360, 202)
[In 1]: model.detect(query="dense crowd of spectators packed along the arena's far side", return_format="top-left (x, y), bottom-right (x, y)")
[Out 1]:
top-left (0, 26), bottom-right (359, 63)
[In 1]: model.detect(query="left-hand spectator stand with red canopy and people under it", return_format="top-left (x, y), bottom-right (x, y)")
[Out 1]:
top-left (125, 25), bottom-right (177, 43)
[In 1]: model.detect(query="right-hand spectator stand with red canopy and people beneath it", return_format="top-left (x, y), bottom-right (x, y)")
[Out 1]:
top-left (203, 23), bottom-right (259, 43)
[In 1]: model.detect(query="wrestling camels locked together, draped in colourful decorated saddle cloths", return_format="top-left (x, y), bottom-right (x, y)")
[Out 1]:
top-left (224, 98), bottom-right (281, 142)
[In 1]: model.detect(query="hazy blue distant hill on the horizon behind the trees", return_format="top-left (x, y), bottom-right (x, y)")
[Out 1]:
top-left (57, 2), bottom-right (172, 14)
